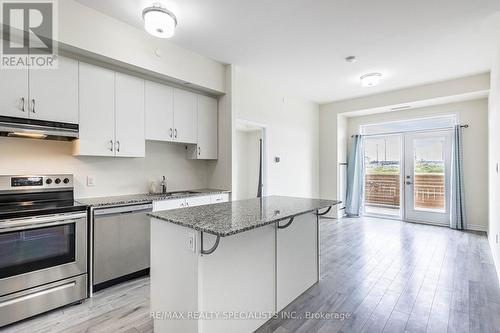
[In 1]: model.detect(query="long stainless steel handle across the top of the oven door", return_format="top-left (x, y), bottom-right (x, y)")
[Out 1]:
top-left (0, 213), bottom-right (87, 233)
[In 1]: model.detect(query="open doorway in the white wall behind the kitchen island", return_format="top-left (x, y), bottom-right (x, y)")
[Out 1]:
top-left (233, 119), bottom-right (267, 200)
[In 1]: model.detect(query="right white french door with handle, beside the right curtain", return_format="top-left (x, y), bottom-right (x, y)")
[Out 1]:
top-left (403, 131), bottom-right (452, 225)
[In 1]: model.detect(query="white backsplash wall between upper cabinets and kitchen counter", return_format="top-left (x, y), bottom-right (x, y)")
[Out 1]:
top-left (0, 138), bottom-right (208, 198)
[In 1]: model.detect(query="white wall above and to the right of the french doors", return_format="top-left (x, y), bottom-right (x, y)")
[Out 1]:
top-left (344, 99), bottom-right (488, 231)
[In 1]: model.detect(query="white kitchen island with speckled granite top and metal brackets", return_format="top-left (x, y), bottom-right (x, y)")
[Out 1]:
top-left (146, 196), bottom-right (339, 333)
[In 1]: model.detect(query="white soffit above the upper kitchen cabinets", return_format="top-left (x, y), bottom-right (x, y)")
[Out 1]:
top-left (58, 0), bottom-right (226, 92)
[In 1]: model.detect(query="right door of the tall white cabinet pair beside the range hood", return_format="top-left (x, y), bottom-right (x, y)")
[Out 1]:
top-left (115, 73), bottom-right (146, 157)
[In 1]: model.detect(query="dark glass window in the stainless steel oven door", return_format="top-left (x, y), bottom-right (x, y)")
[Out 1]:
top-left (0, 223), bottom-right (75, 278)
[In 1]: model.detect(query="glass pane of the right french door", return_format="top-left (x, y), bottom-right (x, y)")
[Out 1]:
top-left (413, 136), bottom-right (446, 212)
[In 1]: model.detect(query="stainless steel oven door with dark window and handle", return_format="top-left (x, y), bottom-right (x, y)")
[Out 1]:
top-left (0, 212), bottom-right (87, 296)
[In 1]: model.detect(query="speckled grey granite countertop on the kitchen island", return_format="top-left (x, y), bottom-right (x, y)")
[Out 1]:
top-left (148, 196), bottom-right (340, 237)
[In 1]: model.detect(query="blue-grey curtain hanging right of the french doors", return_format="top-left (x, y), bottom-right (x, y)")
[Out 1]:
top-left (450, 125), bottom-right (467, 230)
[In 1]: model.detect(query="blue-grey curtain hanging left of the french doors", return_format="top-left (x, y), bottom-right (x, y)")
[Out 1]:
top-left (345, 135), bottom-right (364, 216)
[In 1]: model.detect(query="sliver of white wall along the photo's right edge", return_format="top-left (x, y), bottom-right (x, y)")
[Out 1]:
top-left (488, 32), bottom-right (500, 279)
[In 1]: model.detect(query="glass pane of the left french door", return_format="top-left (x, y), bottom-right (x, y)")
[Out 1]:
top-left (364, 136), bottom-right (401, 216)
